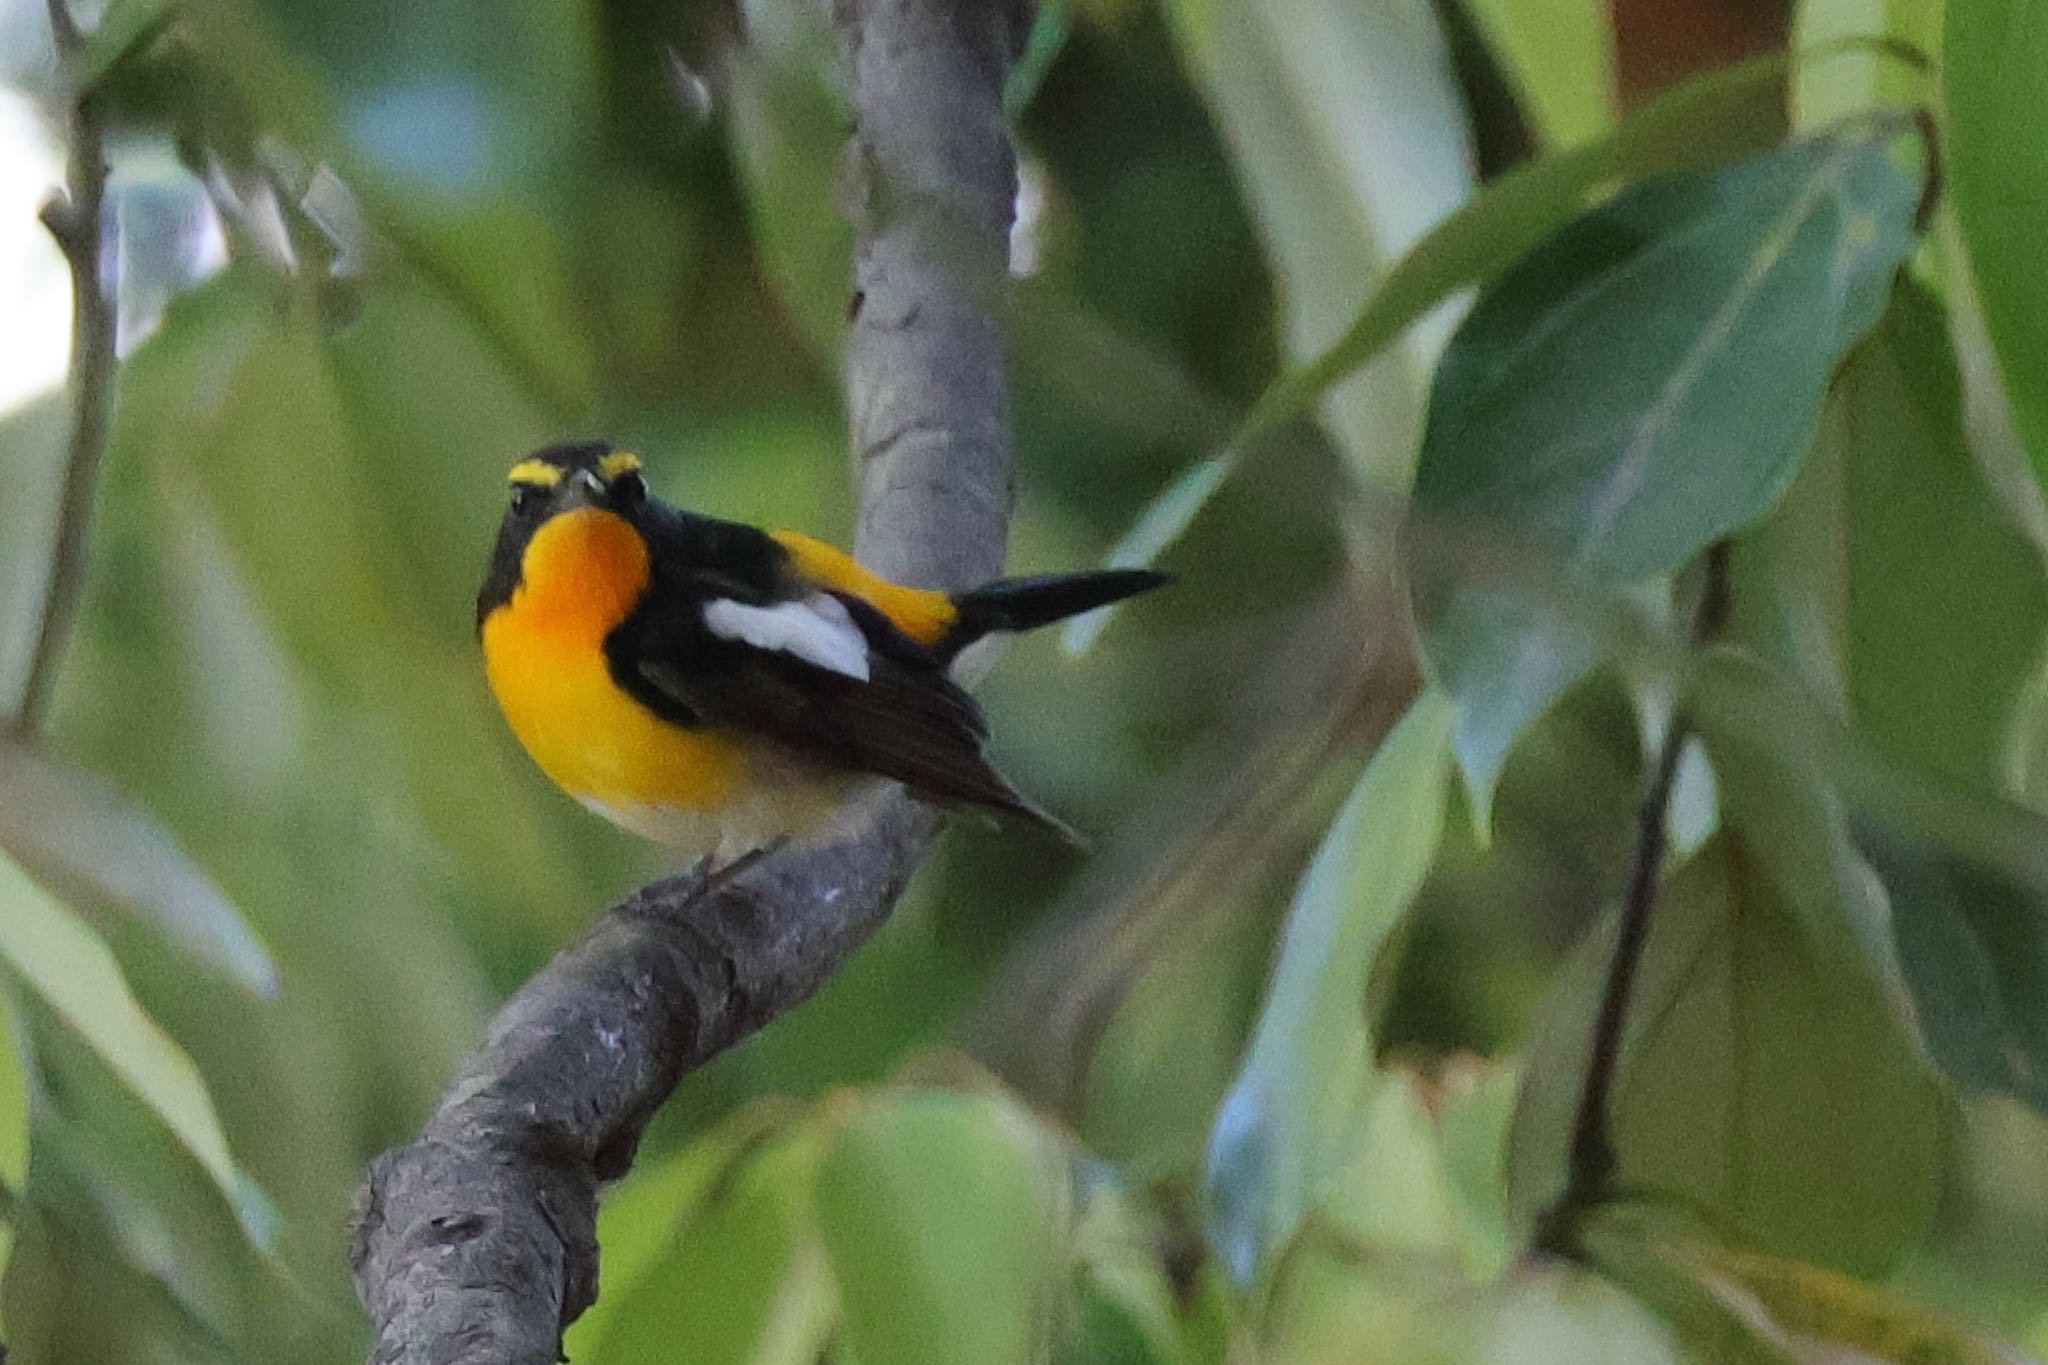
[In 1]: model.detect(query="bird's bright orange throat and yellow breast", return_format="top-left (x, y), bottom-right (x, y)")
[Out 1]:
top-left (483, 508), bottom-right (745, 818)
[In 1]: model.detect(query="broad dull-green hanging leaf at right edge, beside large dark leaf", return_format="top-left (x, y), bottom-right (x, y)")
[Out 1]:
top-left (1729, 280), bottom-right (2048, 790)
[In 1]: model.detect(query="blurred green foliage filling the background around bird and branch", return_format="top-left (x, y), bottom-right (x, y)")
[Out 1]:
top-left (0, 0), bottom-right (2048, 1365)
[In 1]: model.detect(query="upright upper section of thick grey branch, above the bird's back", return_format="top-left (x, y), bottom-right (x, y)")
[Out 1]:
top-left (836, 0), bottom-right (1030, 589)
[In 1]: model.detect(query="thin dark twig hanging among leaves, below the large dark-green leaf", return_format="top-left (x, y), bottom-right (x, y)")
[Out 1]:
top-left (1536, 540), bottom-right (1729, 1254)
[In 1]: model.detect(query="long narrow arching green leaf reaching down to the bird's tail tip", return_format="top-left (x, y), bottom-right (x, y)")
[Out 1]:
top-left (1067, 45), bottom-right (1786, 653)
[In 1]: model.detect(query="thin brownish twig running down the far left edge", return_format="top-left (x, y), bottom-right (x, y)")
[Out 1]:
top-left (8, 0), bottom-right (115, 737)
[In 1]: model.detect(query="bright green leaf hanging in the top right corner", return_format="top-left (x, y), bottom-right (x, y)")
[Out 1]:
top-left (1942, 0), bottom-right (2048, 497)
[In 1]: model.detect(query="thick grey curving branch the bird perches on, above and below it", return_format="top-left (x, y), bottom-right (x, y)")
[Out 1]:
top-left (350, 0), bottom-right (1024, 1365)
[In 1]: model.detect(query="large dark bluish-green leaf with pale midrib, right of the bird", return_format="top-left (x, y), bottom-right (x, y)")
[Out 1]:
top-left (1415, 123), bottom-right (1919, 823)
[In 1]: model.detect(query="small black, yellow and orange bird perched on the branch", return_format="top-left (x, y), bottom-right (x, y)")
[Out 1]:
top-left (477, 440), bottom-right (1167, 866)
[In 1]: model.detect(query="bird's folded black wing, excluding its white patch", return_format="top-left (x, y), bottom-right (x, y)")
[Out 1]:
top-left (604, 575), bottom-right (1071, 837)
